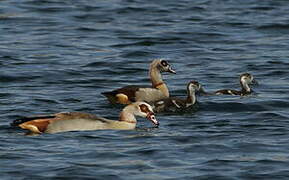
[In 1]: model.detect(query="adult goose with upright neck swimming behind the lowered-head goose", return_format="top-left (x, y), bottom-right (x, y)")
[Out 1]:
top-left (102, 59), bottom-right (176, 104)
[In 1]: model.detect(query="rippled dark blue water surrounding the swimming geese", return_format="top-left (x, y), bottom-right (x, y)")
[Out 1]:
top-left (0, 0), bottom-right (289, 180)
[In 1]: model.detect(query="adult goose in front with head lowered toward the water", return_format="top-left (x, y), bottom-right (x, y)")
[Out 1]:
top-left (11, 102), bottom-right (159, 133)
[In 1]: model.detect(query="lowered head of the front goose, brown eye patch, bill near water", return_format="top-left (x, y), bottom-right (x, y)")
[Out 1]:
top-left (133, 102), bottom-right (159, 127)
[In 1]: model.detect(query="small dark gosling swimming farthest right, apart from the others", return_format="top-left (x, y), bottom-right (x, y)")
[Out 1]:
top-left (215, 73), bottom-right (257, 96)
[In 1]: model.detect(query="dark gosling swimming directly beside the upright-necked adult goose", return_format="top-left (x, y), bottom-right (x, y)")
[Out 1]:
top-left (152, 81), bottom-right (201, 112)
